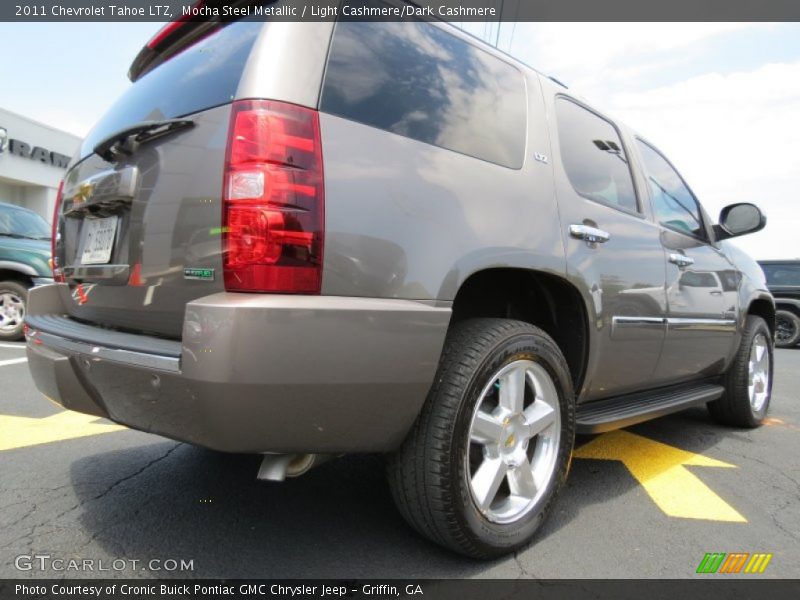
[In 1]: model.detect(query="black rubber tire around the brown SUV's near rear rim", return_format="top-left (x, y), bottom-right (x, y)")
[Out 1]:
top-left (387, 319), bottom-right (575, 559)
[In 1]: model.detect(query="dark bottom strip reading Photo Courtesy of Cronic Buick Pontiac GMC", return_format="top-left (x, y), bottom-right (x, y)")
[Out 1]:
top-left (0, 576), bottom-right (800, 600)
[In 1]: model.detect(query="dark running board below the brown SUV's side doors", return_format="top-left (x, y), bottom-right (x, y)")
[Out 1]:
top-left (576, 383), bottom-right (725, 434)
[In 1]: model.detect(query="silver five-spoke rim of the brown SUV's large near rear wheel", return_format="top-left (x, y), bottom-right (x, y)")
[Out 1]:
top-left (466, 360), bottom-right (561, 523)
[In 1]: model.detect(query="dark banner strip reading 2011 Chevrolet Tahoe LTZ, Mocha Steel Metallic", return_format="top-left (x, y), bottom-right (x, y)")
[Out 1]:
top-left (0, 0), bottom-right (800, 22)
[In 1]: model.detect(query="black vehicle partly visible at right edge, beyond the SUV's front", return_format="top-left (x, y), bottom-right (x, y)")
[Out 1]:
top-left (760, 260), bottom-right (800, 348)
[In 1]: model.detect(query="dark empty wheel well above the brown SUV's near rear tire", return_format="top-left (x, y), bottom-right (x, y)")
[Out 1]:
top-left (450, 267), bottom-right (589, 390)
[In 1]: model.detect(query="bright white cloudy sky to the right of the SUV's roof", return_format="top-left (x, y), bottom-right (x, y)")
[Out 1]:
top-left (500, 23), bottom-right (800, 258)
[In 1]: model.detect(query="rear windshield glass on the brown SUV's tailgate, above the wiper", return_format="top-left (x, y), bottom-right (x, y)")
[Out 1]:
top-left (81, 21), bottom-right (263, 158)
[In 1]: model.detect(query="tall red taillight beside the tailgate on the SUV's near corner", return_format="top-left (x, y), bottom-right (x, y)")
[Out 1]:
top-left (223, 100), bottom-right (325, 294)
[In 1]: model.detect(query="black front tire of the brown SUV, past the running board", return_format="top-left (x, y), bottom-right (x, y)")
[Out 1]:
top-left (708, 315), bottom-right (773, 428)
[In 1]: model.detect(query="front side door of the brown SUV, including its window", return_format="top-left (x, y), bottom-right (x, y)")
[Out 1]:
top-left (636, 139), bottom-right (739, 382)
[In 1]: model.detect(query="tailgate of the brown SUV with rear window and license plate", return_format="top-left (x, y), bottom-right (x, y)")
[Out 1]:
top-left (56, 21), bottom-right (263, 338)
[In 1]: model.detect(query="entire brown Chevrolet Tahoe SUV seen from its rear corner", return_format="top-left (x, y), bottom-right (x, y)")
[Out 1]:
top-left (26, 2), bottom-right (775, 557)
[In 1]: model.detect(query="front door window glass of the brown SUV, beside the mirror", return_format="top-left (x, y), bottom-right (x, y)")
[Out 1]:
top-left (637, 140), bottom-right (706, 238)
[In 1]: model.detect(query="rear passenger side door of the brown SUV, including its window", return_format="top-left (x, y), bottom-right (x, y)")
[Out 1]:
top-left (543, 91), bottom-right (666, 399)
